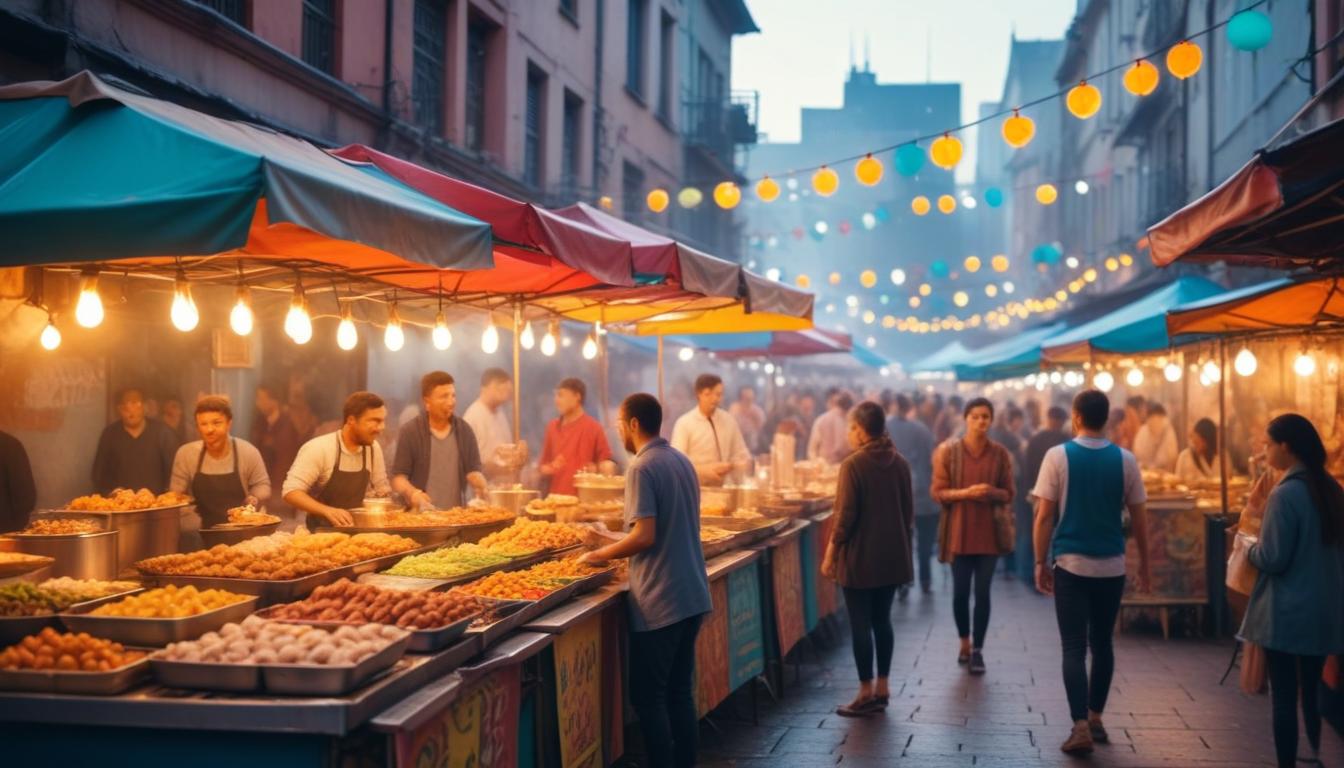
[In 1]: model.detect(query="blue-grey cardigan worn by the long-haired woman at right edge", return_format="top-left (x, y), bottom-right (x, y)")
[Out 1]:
top-left (1241, 467), bottom-right (1344, 656)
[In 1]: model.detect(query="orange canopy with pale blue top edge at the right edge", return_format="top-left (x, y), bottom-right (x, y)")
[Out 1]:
top-left (1167, 277), bottom-right (1344, 336)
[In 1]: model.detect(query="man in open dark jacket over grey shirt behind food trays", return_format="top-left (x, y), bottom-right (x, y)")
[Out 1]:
top-left (392, 371), bottom-right (485, 508)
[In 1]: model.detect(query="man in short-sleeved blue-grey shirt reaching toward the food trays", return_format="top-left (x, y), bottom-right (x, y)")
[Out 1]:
top-left (582, 393), bottom-right (714, 768)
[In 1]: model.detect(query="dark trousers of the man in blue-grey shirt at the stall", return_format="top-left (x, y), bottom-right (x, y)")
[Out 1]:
top-left (630, 616), bottom-right (704, 768)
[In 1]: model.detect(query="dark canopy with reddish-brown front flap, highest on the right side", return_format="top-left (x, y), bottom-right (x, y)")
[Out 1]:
top-left (1148, 120), bottom-right (1344, 269)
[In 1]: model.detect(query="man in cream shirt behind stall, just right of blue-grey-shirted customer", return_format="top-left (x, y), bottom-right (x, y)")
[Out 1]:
top-left (672, 374), bottom-right (751, 486)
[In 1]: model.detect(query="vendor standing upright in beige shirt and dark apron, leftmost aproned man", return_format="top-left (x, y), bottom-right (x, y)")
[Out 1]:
top-left (168, 403), bottom-right (270, 527)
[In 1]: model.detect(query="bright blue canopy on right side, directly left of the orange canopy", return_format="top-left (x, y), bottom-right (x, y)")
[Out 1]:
top-left (1040, 277), bottom-right (1223, 364)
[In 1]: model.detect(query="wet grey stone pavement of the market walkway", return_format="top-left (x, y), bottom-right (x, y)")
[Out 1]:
top-left (702, 573), bottom-right (1344, 768)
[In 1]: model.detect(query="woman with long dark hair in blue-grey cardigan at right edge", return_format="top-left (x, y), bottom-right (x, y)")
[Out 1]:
top-left (1239, 413), bottom-right (1344, 768)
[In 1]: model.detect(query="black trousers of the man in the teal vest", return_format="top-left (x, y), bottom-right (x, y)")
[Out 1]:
top-left (1055, 566), bottom-right (1125, 722)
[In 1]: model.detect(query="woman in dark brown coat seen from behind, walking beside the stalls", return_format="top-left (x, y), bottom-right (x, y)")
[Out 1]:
top-left (821, 402), bottom-right (915, 717)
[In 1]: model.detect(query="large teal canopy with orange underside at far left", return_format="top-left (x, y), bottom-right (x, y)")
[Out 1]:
top-left (0, 71), bottom-right (493, 269)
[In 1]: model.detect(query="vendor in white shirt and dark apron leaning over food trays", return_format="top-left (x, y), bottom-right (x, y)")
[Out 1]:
top-left (284, 391), bottom-right (392, 526)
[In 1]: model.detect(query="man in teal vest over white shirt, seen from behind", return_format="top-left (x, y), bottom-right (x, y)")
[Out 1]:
top-left (1032, 390), bottom-right (1150, 755)
